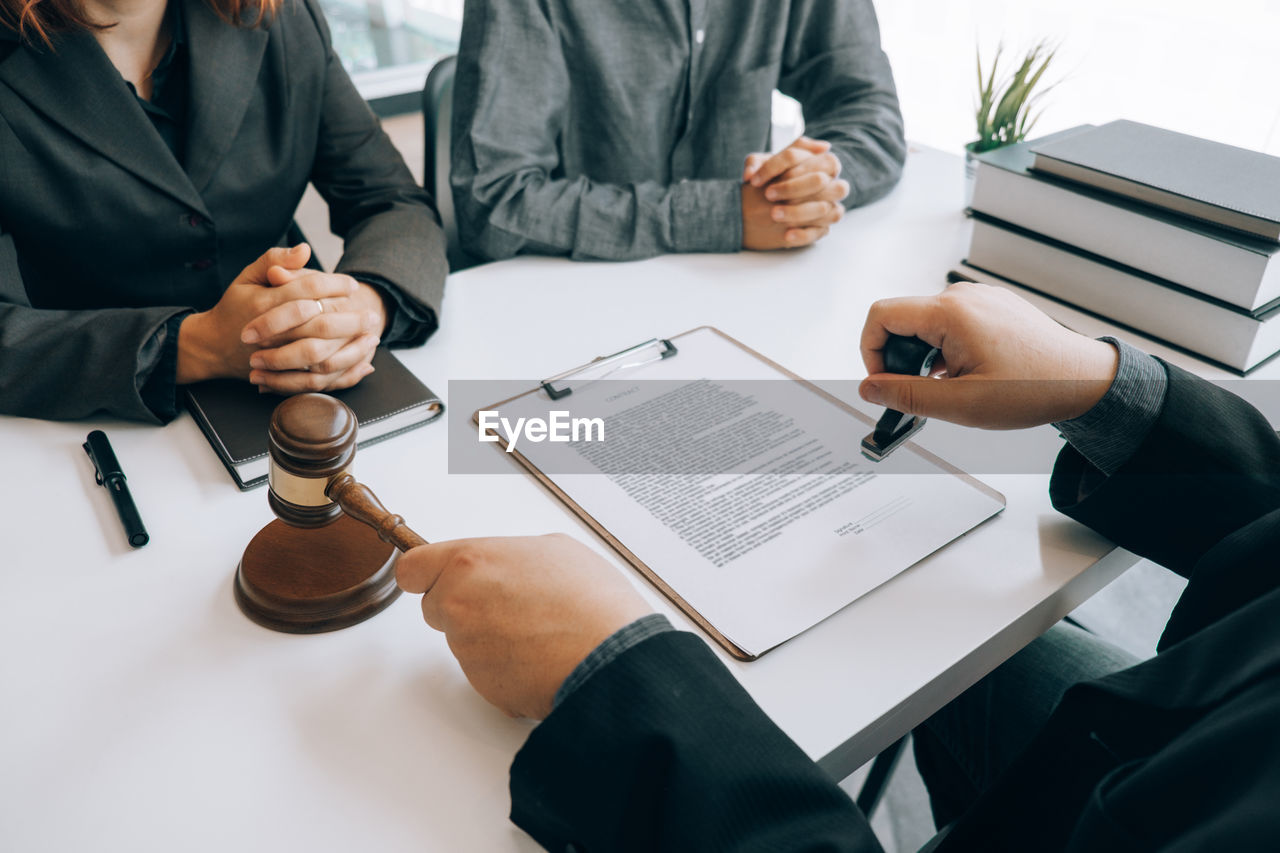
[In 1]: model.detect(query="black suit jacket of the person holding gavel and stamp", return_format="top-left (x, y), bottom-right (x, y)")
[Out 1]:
top-left (511, 368), bottom-right (1280, 853)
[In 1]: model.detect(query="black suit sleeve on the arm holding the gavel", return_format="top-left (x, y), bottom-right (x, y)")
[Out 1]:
top-left (511, 631), bottom-right (881, 853)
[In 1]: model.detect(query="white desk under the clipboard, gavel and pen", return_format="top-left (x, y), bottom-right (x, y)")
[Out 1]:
top-left (0, 151), bottom-right (1269, 853)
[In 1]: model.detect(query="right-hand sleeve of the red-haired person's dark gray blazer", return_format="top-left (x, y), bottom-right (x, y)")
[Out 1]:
top-left (299, 0), bottom-right (449, 346)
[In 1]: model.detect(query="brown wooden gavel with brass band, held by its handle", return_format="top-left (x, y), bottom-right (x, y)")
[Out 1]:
top-left (266, 393), bottom-right (426, 551)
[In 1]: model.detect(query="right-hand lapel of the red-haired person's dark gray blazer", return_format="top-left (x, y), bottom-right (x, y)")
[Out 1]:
top-left (183, 0), bottom-right (268, 191)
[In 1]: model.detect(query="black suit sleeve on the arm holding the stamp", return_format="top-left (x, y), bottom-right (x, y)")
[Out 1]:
top-left (1050, 364), bottom-right (1280, 591)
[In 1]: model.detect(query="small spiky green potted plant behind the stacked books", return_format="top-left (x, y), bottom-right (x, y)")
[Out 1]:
top-left (964, 41), bottom-right (1056, 205)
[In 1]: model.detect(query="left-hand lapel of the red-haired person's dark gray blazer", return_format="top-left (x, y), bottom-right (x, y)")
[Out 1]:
top-left (0, 31), bottom-right (209, 215)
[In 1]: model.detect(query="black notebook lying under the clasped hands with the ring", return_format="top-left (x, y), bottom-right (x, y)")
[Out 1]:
top-left (187, 348), bottom-right (444, 491)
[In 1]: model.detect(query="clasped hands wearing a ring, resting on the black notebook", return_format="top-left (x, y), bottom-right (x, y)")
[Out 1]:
top-left (178, 243), bottom-right (387, 393)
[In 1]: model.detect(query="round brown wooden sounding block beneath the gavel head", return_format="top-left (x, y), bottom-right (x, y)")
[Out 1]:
top-left (236, 516), bottom-right (401, 634)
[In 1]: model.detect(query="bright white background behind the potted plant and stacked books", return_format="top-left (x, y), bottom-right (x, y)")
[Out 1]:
top-left (876, 0), bottom-right (1280, 155)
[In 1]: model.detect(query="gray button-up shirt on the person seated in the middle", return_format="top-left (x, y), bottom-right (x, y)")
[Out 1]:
top-left (452, 0), bottom-right (906, 260)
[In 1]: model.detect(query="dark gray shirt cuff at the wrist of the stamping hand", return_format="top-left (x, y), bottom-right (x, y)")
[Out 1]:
top-left (1053, 337), bottom-right (1169, 476)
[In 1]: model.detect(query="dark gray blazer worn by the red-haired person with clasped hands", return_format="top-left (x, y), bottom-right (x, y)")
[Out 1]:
top-left (0, 0), bottom-right (448, 421)
